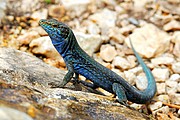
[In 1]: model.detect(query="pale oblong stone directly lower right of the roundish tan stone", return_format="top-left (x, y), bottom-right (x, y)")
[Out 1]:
top-left (113, 56), bottom-right (131, 70)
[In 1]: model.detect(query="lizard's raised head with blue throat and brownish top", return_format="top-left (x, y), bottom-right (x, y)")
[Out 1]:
top-left (39, 19), bottom-right (70, 45)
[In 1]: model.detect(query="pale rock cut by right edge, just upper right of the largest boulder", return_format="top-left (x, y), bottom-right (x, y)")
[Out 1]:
top-left (163, 20), bottom-right (180, 31)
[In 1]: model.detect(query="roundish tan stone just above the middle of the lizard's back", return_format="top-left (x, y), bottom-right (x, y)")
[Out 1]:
top-left (100, 44), bottom-right (117, 62)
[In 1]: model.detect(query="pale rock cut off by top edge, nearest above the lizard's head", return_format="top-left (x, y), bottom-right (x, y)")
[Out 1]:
top-left (61, 0), bottom-right (91, 18)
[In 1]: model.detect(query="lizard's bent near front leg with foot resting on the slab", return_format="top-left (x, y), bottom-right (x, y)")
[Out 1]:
top-left (50, 62), bottom-right (75, 88)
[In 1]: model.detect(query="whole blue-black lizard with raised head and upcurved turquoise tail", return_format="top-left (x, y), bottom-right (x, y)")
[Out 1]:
top-left (39, 19), bottom-right (157, 105)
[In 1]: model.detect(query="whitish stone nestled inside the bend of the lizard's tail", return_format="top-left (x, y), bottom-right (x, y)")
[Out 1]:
top-left (136, 76), bottom-right (148, 90)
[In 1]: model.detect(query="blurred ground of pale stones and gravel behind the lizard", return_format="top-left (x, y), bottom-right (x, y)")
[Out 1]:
top-left (0, 0), bottom-right (180, 120)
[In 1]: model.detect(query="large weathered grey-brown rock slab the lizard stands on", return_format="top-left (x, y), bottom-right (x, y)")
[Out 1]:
top-left (0, 48), bottom-right (148, 120)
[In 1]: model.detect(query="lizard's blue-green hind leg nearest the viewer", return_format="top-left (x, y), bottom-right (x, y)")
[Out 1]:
top-left (112, 83), bottom-right (128, 106)
